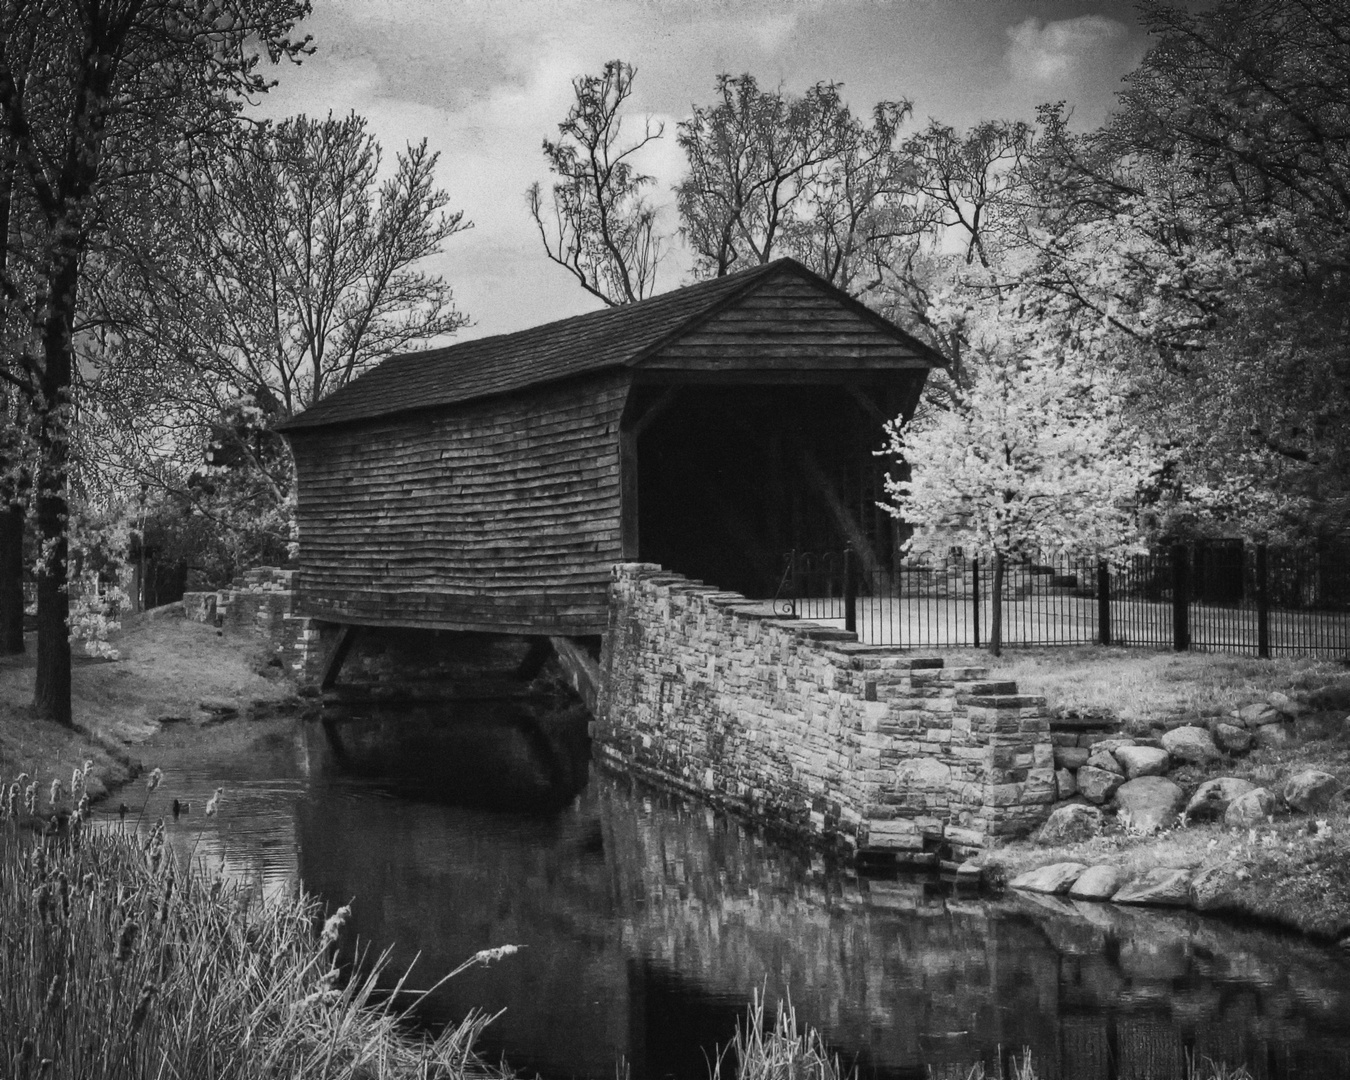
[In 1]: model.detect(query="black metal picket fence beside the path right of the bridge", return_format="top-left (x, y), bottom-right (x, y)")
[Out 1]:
top-left (775, 543), bottom-right (1350, 656)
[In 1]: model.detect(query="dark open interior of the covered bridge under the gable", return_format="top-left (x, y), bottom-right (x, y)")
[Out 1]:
top-left (630, 382), bottom-right (902, 597)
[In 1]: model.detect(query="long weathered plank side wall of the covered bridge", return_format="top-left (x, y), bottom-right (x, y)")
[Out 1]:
top-left (290, 373), bottom-right (629, 635)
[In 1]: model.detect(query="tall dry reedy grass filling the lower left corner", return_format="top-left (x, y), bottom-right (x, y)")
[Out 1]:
top-left (0, 766), bottom-right (500, 1080)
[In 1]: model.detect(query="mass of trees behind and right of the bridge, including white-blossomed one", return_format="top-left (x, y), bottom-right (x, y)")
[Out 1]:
top-left (531, 0), bottom-right (1350, 658)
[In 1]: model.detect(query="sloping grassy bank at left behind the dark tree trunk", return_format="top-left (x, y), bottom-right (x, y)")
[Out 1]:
top-left (0, 610), bottom-right (294, 797)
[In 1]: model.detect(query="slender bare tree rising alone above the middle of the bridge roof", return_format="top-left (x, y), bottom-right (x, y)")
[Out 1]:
top-left (525, 59), bottom-right (666, 306)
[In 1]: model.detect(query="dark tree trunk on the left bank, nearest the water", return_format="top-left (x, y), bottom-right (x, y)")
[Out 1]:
top-left (32, 252), bottom-right (80, 726)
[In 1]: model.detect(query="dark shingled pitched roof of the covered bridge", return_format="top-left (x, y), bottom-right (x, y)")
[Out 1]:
top-left (278, 259), bottom-right (942, 431)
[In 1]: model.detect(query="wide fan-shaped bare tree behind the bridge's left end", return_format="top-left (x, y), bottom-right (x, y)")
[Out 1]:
top-left (77, 115), bottom-right (468, 572)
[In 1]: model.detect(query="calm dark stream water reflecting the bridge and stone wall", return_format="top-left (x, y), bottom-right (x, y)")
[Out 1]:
top-left (99, 718), bottom-right (1350, 1080)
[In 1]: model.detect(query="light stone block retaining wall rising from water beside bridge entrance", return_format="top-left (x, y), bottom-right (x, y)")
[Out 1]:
top-left (595, 563), bottom-right (1054, 859)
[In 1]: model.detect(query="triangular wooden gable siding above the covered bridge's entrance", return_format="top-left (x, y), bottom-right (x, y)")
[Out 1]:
top-left (639, 274), bottom-right (932, 374)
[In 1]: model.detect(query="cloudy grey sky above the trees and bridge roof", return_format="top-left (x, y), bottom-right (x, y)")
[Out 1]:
top-left (257, 0), bottom-right (1148, 340)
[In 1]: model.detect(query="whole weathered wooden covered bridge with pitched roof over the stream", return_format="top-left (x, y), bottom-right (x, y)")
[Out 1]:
top-left (282, 259), bottom-right (941, 636)
